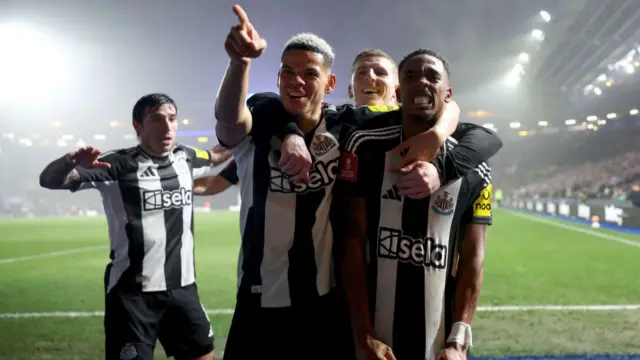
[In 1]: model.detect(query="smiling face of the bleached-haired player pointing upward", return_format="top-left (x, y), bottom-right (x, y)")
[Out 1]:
top-left (278, 50), bottom-right (336, 117)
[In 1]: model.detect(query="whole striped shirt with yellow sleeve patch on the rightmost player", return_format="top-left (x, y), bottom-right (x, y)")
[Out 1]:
top-left (335, 111), bottom-right (491, 360)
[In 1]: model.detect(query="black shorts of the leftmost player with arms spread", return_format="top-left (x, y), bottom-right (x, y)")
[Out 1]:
top-left (104, 284), bottom-right (213, 360)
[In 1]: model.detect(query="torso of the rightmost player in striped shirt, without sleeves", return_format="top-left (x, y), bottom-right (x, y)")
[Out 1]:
top-left (361, 136), bottom-right (467, 359)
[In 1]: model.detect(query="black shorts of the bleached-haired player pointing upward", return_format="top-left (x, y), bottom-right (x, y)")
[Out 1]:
top-left (224, 290), bottom-right (355, 360)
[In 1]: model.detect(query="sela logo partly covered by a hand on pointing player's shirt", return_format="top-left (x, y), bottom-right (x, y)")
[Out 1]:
top-left (270, 158), bottom-right (340, 194)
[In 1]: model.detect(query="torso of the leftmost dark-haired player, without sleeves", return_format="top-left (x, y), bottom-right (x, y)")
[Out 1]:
top-left (103, 148), bottom-right (194, 291)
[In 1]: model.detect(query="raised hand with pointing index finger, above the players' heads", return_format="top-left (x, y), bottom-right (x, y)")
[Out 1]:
top-left (224, 5), bottom-right (267, 63)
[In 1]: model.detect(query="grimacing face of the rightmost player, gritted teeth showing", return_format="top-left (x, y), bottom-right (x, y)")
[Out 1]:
top-left (398, 54), bottom-right (452, 120)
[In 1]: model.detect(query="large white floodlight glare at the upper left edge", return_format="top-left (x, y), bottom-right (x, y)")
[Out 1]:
top-left (0, 23), bottom-right (69, 104)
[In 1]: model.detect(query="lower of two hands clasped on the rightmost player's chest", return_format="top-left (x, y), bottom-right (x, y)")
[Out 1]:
top-left (396, 161), bottom-right (440, 199)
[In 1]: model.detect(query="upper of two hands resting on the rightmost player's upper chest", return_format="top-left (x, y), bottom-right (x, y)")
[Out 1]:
top-left (389, 129), bottom-right (446, 172)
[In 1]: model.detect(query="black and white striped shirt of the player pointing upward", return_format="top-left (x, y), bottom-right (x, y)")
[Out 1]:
top-left (223, 93), bottom-right (340, 308)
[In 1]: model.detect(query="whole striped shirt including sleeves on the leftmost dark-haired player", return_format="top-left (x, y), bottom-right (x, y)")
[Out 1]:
top-left (71, 145), bottom-right (212, 292)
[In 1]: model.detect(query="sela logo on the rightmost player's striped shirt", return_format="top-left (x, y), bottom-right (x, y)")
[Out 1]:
top-left (378, 227), bottom-right (448, 269)
